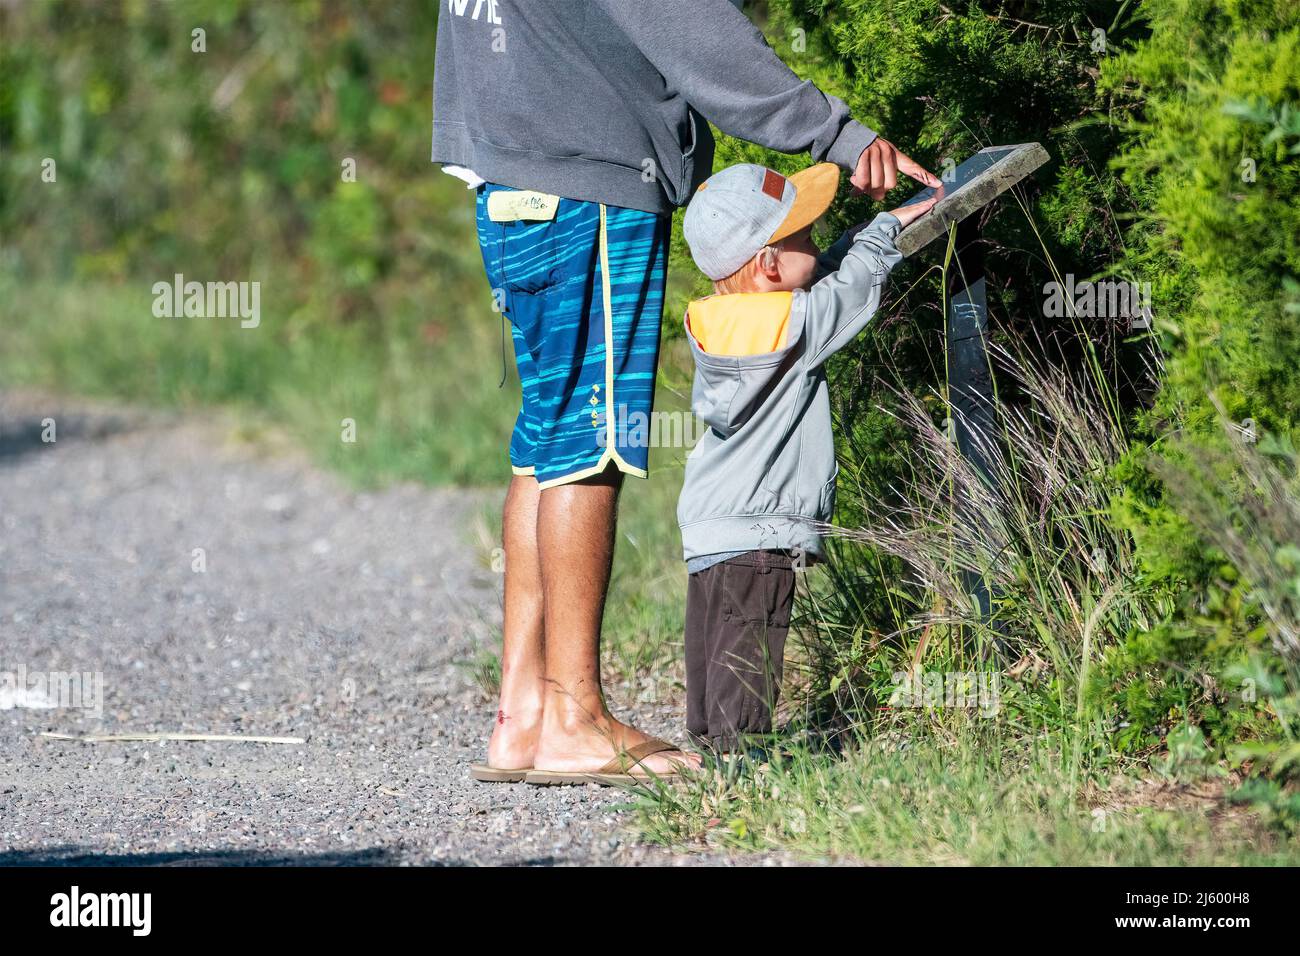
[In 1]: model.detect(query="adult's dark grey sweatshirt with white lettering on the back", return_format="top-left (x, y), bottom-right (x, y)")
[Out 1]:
top-left (433, 0), bottom-right (875, 213)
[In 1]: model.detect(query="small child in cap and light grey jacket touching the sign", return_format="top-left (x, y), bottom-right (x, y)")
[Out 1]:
top-left (677, 163), bottom-right (935, 753)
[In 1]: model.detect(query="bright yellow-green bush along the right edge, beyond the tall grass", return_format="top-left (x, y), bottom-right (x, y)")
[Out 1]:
top-left (1101, 0), bottom-right (1300, 764)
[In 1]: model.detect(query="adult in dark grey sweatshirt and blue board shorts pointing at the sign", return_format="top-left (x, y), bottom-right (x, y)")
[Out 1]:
top-left (433, 0), bottom-right (939, 783)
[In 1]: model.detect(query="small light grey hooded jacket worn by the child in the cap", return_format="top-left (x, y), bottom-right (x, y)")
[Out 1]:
top-left (677, 212), bottom-right (902, 561)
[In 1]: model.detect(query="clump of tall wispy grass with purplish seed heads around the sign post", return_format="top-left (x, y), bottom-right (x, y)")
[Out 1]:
top-left (780, 346), bottom-right (1167, 749)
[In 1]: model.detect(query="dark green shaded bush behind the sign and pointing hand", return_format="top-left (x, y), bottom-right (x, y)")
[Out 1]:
top-left (719, 0), bottom-right (1144, 564)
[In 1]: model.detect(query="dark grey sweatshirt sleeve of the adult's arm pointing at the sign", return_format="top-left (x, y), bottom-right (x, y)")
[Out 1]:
top-left (593, 0), bottom-right (876, 169)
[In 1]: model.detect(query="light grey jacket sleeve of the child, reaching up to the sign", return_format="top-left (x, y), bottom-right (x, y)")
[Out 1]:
top-left (803, 212), bottom-right (902, 368)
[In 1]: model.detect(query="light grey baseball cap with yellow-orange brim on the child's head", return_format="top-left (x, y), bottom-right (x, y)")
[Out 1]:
top-left (683, 163), bottom-right (840, 280)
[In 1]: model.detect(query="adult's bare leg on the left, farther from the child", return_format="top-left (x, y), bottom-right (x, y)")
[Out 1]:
top-left (488, 475), bottom-right (545, 770)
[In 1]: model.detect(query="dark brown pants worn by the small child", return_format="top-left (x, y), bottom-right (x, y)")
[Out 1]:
top-left (686, 551), bottom-right (794, 752)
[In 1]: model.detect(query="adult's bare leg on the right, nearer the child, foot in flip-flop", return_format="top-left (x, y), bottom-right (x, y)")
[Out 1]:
top-left (534, 466), bottom-right (686, 773)
